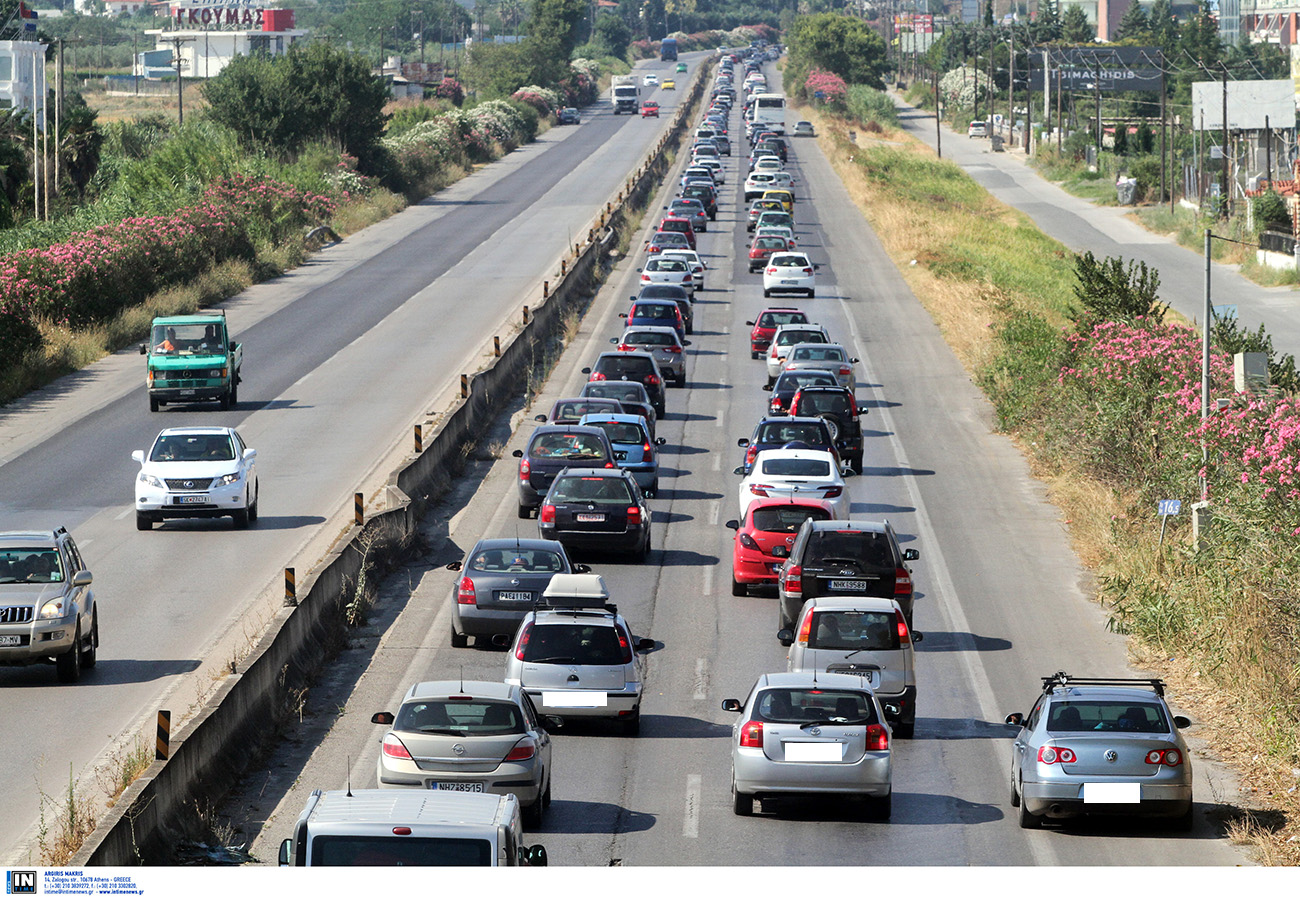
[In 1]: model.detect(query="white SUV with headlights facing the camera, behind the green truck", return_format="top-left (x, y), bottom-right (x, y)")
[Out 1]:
top-left (131, 426), bottom-right (257, 529)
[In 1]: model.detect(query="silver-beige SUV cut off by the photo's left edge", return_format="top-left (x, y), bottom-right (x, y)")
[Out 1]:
top-left (0, 527), bottom-right (99, 683)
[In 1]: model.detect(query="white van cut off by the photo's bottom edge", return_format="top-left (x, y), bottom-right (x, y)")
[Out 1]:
top-left (280, 789), bottom-right (546, 866)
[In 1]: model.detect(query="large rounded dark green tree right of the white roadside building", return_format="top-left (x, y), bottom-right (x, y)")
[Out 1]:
top-left (203, 42), bottom-right (389, 173)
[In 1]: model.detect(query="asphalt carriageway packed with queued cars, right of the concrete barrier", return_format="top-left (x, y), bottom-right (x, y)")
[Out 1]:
top-left (218, 64), bottom-right (1244, 866)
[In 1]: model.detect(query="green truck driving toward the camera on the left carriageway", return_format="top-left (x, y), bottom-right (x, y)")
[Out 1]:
top-left (140, 312), bottom-right (243, 411)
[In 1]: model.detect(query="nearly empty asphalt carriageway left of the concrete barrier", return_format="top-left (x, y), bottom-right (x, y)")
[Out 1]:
top-left (0, 55), bottom-right (705, 862)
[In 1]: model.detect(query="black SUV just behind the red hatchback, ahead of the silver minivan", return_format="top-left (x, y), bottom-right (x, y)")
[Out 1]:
top-left (776, 520), bottom-right (920, 629)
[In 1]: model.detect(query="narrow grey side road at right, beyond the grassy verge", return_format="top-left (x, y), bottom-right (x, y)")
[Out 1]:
top-left (891, 94), bottom-right (1300, 354)
